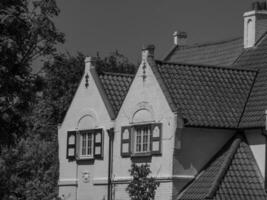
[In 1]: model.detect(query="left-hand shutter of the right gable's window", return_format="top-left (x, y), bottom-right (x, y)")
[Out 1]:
top-left (121, 126), bottom-right (131, 157)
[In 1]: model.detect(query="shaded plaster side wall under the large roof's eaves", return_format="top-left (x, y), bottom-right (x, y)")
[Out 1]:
top-left (173, 128), bottom-right (235, 176)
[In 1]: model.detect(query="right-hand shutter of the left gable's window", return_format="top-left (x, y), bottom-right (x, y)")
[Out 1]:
top-left (94, 129), bottom-right (104, 159)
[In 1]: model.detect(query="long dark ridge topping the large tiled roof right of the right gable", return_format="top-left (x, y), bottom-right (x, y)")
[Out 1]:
top-left (155, 60), bottom-right (258, 72)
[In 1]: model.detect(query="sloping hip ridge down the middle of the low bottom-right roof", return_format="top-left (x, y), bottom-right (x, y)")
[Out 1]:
top-left (207, 133), bottom-right (242, 198)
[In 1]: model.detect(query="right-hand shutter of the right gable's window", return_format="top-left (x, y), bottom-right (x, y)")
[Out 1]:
top-left (151, 123), bottom-right (162, 155)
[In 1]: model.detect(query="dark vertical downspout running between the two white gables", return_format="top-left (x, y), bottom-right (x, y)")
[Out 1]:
top-left (108, 128), bottom-right (114, 200)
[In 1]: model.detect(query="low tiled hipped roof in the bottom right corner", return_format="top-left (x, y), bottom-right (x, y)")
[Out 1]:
top-left (178, 135), bottom-right (267, 200)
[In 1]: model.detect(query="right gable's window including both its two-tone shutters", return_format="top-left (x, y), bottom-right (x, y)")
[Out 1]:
top-left (121, 123), bottom-right (161, 157)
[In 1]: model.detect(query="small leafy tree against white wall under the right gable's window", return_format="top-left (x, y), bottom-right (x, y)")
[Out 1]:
top-left (126, 163), bottom-right (159, 200)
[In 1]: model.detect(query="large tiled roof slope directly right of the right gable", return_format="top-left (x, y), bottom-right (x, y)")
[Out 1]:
top-left (156, 61), bottom-right (257, 128)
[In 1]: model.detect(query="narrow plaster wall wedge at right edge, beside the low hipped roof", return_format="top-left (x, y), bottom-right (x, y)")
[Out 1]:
top-left (245, 129), bottom-right (266, 177)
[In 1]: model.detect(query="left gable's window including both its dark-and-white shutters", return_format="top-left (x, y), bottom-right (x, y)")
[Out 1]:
top-left (67, 129), bottom-right (103, 160)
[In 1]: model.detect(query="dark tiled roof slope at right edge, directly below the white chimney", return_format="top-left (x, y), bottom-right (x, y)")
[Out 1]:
top-left (234, 34), bottom-right (267, 128)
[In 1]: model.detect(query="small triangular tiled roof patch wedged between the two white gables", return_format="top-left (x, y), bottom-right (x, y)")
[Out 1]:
top-left (99, 72), bottom-right (134, 116)
